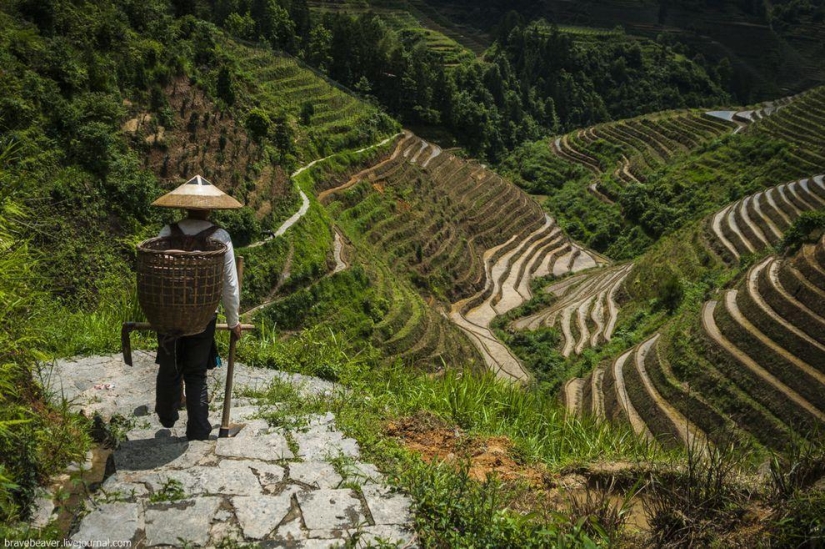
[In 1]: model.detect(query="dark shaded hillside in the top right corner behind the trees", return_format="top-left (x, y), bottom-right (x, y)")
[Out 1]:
top-left (428, 0), bottom-right (825, 102)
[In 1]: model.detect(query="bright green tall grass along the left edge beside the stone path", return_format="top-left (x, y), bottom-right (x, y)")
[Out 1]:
top-left (0, 194), bottom-right (88, 532)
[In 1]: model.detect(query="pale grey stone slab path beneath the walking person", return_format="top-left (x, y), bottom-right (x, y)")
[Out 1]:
top-left (39, 351), bottom-right (416, 549)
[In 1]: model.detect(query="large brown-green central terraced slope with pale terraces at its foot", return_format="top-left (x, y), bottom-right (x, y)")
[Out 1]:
top-left (326, 132), bottom-right (609, 380)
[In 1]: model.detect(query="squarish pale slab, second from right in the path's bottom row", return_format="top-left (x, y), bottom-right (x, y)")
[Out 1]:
top-left (295, 490), bottom-right (366, 530)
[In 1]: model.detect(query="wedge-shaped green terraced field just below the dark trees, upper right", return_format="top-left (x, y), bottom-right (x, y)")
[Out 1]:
top-left (551, 112), bottom-right (737, 203)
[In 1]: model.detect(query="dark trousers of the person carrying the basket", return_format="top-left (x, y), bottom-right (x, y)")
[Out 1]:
top-left (155, 318), bottom-right (216, 440)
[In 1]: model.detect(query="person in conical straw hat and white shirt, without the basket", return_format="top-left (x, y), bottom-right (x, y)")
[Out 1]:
top-left (152, 175), bottom-right (243, 440)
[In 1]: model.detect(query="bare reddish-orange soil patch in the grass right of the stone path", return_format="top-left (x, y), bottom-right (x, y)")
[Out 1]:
top-left (387, 414), bottom-right (547, 486)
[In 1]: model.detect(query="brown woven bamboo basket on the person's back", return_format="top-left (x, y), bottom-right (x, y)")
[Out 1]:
top-left (137, 237), bottom-right (227, 337)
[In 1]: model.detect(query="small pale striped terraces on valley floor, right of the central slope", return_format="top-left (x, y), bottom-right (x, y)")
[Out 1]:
top-left (511, 259), bottom-right (633, 357)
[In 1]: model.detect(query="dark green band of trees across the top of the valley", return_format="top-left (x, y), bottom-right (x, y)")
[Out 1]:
top-left (200, 0), bottom-right (728, 161)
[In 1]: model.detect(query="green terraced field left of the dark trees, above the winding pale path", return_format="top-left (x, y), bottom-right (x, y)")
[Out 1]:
top-left (229, 42), bottom-right (386, 156)
